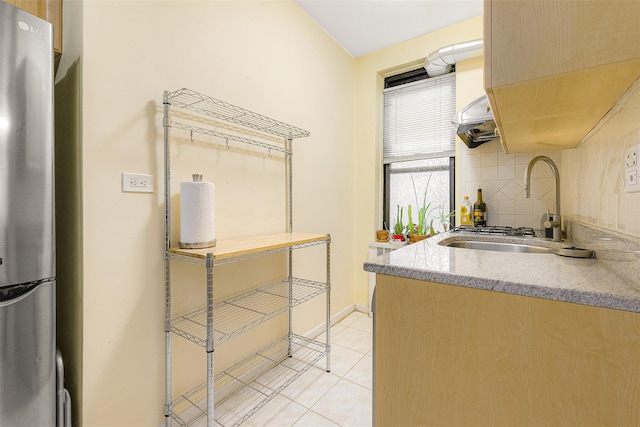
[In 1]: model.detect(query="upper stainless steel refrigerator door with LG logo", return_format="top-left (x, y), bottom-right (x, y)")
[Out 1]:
top-left (0, 1), bottom-right (55, 286)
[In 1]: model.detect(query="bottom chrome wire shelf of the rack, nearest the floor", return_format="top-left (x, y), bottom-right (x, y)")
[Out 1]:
top-left (171, 335), bottom-right (327, 426)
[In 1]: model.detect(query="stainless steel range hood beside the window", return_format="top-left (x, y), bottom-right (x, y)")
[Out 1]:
top-left (452, 95), bottom-right (500, 148)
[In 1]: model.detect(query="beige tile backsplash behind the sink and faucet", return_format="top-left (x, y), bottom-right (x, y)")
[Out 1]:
top-left (456, 80), bottom-right (640, 236)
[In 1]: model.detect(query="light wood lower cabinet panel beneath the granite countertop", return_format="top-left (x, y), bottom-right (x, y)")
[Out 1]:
top-left (374, 275), bottom-right (640, 426)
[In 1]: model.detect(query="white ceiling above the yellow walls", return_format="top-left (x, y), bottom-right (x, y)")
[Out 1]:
top-left (294, 0), bottom-right (483, 58)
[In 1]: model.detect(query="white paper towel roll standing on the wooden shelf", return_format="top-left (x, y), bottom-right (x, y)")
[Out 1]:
top-left (180, 182), bottom-right (216, 249)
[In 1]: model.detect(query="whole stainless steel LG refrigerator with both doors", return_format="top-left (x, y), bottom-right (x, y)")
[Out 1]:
top-left (0, 1), bottom-right (58, 427)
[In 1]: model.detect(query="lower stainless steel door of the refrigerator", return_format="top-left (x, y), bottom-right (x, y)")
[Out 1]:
top-left (0, 282), bottom-right (56, 427)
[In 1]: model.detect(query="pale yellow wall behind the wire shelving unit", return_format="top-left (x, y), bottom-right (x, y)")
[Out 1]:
top-left (60, 1), bottom-right (355, 426)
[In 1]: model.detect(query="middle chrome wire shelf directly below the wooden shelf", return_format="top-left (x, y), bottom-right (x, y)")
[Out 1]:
top-left (171, 278), bottom-right (327, 347)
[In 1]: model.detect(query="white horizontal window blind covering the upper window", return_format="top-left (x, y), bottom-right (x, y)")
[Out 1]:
top-left (383, 73), bottom-right (456, 163)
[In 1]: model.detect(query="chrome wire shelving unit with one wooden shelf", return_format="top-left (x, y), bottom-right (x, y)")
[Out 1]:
top-left (163, 88), bottom-right (331, 427)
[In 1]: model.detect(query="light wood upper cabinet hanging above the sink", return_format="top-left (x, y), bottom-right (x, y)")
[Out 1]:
top-left (484, 0), bottom-right (640, 153)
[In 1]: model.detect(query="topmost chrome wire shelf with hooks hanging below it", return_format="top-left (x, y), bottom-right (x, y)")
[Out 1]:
top-left (165, 88), bottom-right (310, 139)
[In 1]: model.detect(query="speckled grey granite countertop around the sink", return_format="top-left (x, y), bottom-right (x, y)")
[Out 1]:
top-left (364, 226), bottom-right (640, 313)
